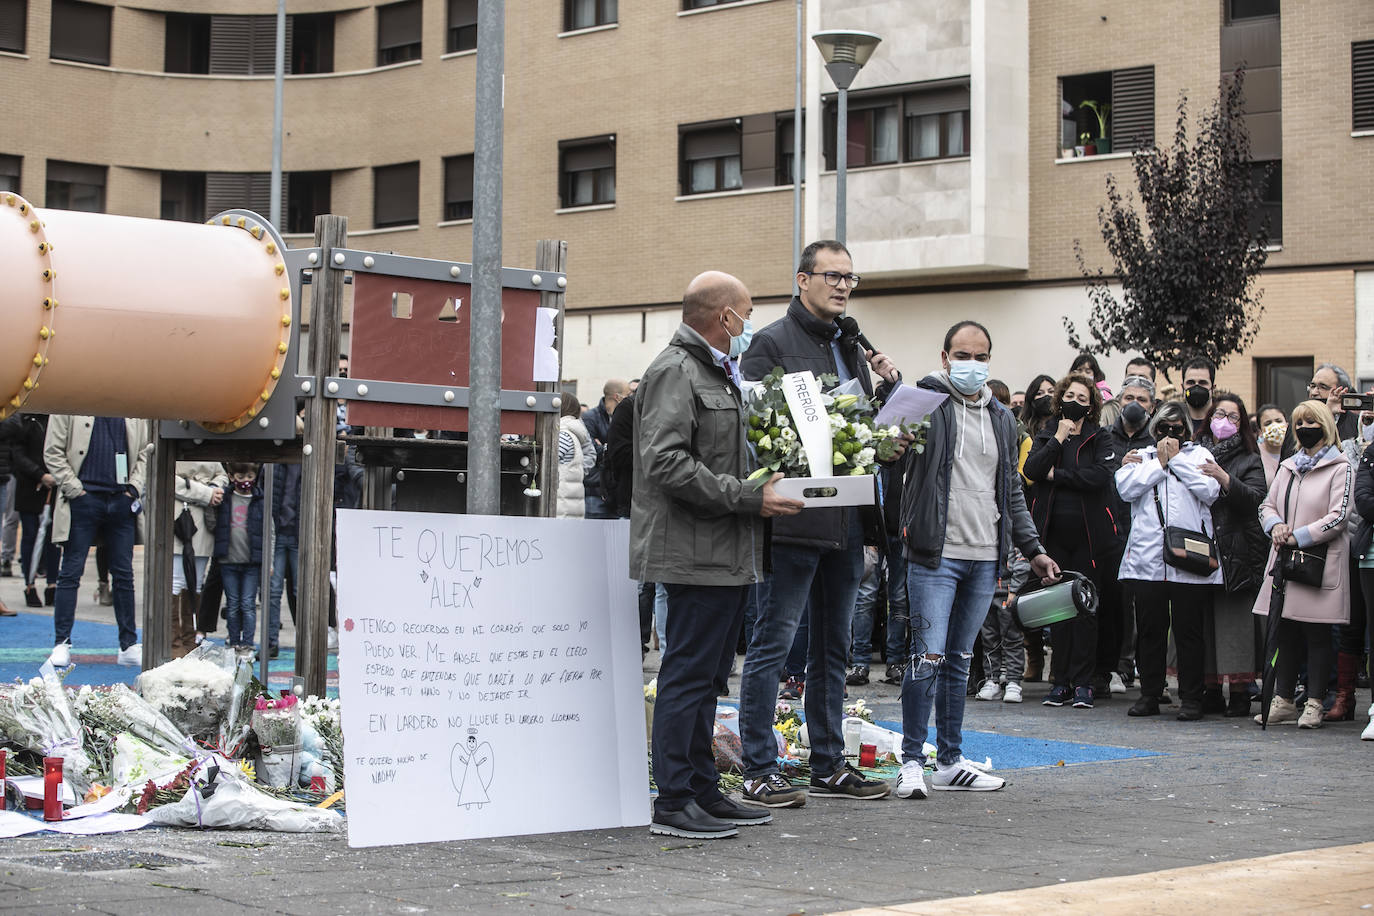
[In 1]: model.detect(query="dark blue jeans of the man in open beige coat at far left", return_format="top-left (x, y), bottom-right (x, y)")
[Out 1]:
top-left (52, 493), bottom-right (139, 651)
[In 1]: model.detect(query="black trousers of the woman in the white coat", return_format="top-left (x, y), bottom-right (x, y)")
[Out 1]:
top-left (1132, 580), bottom-right (1213, 703)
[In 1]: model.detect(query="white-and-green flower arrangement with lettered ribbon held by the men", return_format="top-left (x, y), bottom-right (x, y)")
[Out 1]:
top-left (747, 368), bottom-right (929, 505)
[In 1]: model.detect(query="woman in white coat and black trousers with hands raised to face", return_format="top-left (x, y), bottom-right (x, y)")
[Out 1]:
top-left (1116, 401), bottom-right (1221, 721)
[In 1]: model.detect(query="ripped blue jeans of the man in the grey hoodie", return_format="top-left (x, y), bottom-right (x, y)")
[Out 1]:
top-left (901, 559), bottom-right (998, 766)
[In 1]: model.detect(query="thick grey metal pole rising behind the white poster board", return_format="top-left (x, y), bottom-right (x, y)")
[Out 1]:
top-left (467, 0), bottom-right (506, 515)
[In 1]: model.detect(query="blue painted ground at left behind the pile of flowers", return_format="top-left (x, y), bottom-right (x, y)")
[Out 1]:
top-left (0, 608), bottom-right (338, 698)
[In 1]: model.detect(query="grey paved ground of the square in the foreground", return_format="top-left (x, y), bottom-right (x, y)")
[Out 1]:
top-left (0, 563), bottom-right (1374, 915)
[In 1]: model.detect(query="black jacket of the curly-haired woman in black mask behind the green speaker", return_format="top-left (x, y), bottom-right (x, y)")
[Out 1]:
top-left (1021, 422), bottom-right (1123, 563)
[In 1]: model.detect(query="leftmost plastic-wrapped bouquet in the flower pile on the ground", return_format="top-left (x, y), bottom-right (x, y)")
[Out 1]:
top-left (0, 663), bottom-right (92, 797)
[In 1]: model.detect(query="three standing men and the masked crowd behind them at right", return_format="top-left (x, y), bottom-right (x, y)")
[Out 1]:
top-left (629, 240), bottom-right (1374, 838)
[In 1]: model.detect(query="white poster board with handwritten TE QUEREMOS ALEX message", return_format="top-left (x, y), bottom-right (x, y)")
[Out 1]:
top-left (338, 511), bottom-right (650, 846)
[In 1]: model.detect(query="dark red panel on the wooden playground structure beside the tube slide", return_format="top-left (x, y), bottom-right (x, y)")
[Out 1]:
top-left (348, 272), bottom-right (539, 435)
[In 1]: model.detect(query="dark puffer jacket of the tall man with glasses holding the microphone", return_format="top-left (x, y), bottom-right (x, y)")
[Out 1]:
top-left (739, 297), bottom-right (878, 551)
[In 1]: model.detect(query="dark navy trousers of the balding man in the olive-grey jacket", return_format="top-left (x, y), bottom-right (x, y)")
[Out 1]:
top-left (653, 585), bottom-right (750, 812)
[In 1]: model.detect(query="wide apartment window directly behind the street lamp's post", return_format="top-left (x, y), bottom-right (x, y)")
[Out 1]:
top-left (826, 82), bottom-right (970, 169)
